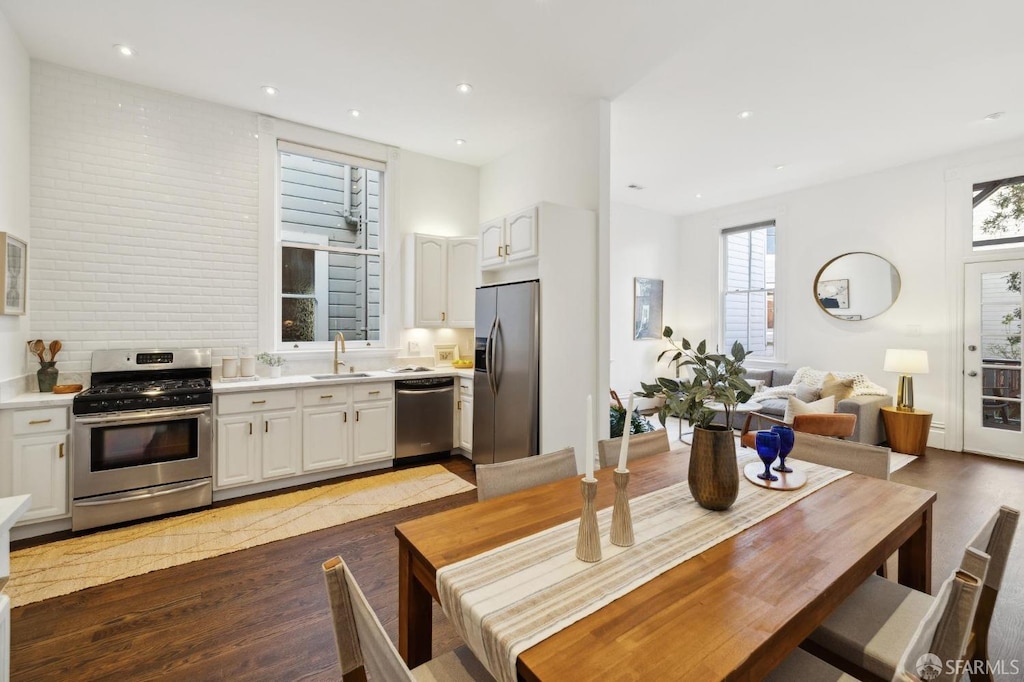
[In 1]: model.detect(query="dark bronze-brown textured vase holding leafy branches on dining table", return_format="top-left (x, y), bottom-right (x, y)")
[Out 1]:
top-left (688, 425), bottom-right (739, 511)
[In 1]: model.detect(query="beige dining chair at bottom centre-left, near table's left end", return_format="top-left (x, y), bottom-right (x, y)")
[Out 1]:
top-left (324, 556), bottom-right (494, 682)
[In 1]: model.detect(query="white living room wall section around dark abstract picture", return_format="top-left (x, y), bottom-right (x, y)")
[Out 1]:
top-left (609, 203), bottom-right (689, 395)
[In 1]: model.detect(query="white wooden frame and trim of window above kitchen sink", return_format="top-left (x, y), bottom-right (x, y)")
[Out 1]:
top-left (257, 116), bottom-right (401, 359)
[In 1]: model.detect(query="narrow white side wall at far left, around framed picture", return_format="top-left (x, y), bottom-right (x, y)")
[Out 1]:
top-left (0, 12), bottom-right (29, 383)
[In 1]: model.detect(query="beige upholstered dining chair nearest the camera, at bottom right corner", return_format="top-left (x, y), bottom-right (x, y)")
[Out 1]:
top-left (765, 561), bottom-right (988, 682)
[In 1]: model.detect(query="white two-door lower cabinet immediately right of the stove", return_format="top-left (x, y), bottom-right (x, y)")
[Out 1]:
top-left (217, 390), bottom-right (302, 487)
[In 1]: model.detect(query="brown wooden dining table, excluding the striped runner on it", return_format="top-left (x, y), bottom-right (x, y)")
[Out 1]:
top-left (395, 453), bottom-right (936, 680)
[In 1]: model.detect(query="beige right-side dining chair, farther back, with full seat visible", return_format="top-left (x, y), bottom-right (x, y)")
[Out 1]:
top-left (801, 507), bottom-right (1020, 679)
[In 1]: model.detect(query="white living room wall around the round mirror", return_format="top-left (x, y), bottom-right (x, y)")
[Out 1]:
top-left (678, 139), bottom-right (1024, 447)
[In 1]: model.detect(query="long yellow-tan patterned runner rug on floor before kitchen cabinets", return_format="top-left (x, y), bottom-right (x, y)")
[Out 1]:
top-left (5, 464), bottom-right (475, 606)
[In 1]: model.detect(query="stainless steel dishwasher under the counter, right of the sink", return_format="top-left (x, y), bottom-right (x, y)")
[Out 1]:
top-left (394, 377), bottom-right (455, 464)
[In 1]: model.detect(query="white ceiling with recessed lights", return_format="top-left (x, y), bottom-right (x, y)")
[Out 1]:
top-left (0, 0), bottom-right (1024, 215)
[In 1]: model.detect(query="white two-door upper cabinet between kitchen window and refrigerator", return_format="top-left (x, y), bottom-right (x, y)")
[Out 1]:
top-left (402, 235), bottom-right (477, 328)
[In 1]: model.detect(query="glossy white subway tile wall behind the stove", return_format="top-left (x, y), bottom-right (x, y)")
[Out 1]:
top-left (29, 61), bottom-right (259, 373)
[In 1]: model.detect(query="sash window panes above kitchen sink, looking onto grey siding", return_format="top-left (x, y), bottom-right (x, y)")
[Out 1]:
top-left (275, 140), bottom-right (385, 348)
